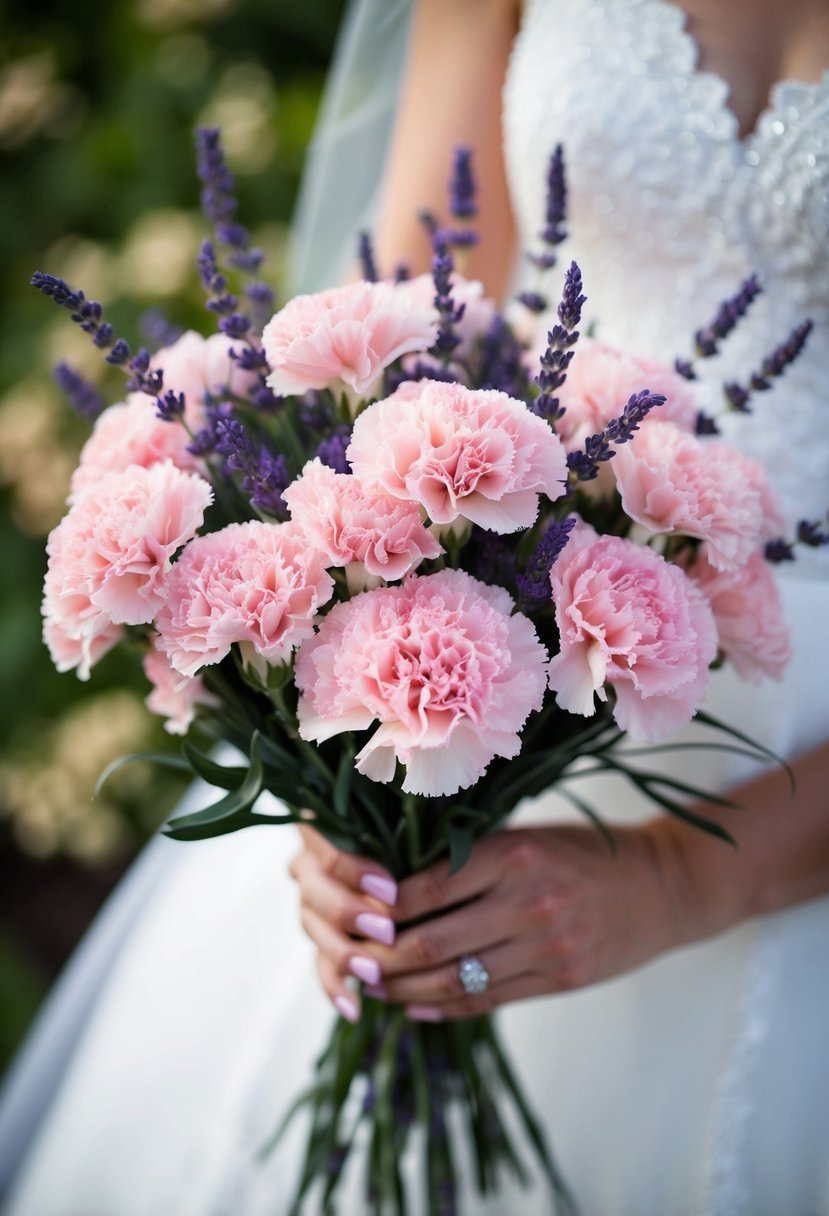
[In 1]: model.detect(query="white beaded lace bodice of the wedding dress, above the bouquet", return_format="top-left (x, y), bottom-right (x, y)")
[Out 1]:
top-left (504, 0), bottom-right (829, 537)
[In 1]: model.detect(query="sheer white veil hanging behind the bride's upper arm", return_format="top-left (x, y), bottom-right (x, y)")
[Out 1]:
top-left (288, 0), bottom-right (412, 292)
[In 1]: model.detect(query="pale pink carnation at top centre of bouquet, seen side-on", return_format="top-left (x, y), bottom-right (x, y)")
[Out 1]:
top-left (263, 282), bottom-right (436, 396)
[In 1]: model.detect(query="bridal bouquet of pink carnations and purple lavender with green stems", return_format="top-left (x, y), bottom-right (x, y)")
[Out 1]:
top-left (34, 130), bottom-right (823, 1216)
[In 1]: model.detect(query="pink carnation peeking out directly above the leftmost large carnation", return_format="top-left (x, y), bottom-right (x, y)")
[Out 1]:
top-left (72, 393), bottom-right (199, 499)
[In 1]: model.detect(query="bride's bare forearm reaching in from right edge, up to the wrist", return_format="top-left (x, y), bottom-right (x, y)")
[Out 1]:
top-left (648, 741), bottom-right (829, 944)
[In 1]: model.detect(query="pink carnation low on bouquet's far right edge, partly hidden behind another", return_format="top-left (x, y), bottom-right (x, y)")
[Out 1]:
top-left (688, 550), bottom-right (791, 683)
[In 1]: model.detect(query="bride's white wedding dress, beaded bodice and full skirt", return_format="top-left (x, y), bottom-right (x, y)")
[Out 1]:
top-left (0, 0), bottom-right (829, 1216)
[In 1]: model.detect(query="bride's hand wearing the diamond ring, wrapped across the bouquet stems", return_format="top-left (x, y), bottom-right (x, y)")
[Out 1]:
top-left (367, 824), bottom-right (682, 1020)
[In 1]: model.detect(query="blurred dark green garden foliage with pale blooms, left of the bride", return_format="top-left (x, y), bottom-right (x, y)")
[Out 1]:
top-left (0, 0), bottom-right (343, 1063)
